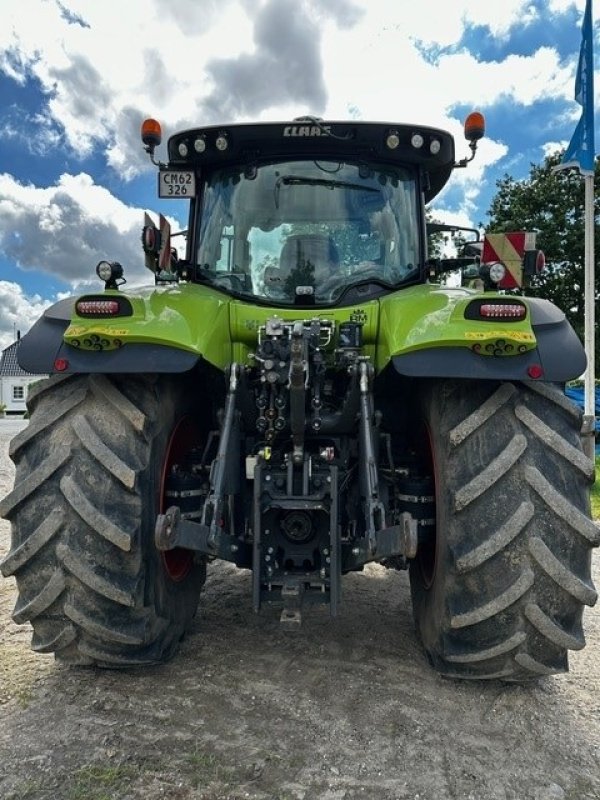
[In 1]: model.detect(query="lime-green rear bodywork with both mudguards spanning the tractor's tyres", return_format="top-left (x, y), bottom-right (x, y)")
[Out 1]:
top-left (18, 284), bottom-right (586, 382)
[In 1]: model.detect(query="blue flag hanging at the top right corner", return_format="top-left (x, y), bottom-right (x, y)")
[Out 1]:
top-left (557, 0), bottom-right (596, 175)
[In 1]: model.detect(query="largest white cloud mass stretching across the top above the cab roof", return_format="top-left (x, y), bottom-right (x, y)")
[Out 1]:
top-left (0, 0), bottom-right (581, 177)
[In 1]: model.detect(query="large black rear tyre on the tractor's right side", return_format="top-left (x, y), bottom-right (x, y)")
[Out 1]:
top-left (410, 381), bottom-right (599, 681)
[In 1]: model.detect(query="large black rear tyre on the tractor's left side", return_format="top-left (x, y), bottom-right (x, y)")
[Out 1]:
top-left (0, 375), bottom-right (206, 667)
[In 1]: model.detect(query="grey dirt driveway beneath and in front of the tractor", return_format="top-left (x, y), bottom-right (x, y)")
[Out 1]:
top-left (0, 426), bottom-right (600, 800)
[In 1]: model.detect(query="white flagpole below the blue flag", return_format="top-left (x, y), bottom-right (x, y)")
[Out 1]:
top-left (582, 174), bottom-right (596, 461)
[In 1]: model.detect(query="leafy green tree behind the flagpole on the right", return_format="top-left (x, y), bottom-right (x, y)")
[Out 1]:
top-left (487, 152), bottom-right (600, 366)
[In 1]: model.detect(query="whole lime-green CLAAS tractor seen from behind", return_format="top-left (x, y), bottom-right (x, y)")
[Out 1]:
top-left (0, 113), bottom-right (599, 681)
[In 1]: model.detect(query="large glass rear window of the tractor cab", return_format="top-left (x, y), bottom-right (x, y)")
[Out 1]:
top-left (197, 161), bottom-right (420, 305)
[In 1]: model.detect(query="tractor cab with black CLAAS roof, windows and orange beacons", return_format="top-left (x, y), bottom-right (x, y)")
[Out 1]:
top-left (142, 115), bottom-right (483, 307)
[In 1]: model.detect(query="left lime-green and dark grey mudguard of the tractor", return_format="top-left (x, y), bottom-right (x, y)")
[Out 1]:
top-left (18, 286), bottom-right (231, 374)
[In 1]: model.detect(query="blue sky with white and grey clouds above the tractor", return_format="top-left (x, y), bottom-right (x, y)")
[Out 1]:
top-left (0, 0), bottom-right (600, 349)
